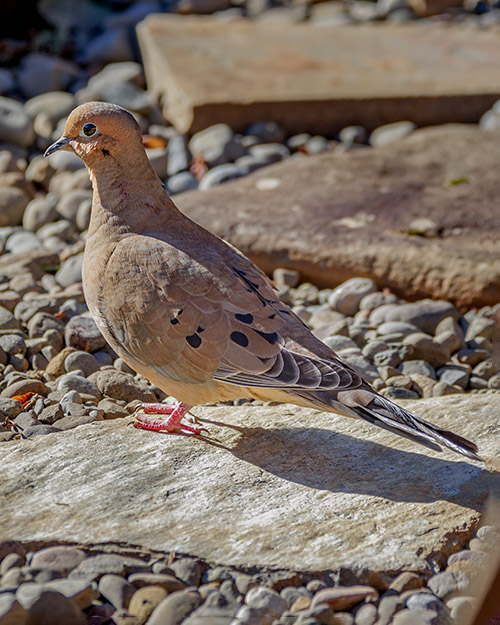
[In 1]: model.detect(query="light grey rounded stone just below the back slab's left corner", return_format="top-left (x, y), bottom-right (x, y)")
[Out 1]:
top-left (189, 124), bottom-right (246, 167)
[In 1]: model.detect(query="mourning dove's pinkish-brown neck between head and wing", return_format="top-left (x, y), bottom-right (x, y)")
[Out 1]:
top-left (88, 153), bottom-right (180, 240)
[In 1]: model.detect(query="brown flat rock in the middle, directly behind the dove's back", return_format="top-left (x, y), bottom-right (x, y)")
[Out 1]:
top-left (175, 125), bottom-right (500, 307)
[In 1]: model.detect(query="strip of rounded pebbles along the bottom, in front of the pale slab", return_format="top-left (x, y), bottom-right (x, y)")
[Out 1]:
top-left (0, 526), bottom-right (500, 625)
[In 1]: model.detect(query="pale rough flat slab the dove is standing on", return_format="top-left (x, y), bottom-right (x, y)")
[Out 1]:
top-left (0, 392), bottom-right (500, 583)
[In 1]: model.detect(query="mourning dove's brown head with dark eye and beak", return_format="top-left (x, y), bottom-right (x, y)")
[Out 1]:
top-left (45, 102), bottom-right (142, 167)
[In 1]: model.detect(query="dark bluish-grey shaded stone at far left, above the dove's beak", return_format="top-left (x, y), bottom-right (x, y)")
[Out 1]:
top-left (17, 52), bottom-right (78, 98)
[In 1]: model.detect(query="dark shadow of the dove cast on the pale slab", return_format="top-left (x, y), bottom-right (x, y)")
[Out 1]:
top-left (196, 419), bottom-right (488, 511)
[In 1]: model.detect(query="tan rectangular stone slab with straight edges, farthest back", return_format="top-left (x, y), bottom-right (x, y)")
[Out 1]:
top-left (137, 14), bottom-right (500, 134)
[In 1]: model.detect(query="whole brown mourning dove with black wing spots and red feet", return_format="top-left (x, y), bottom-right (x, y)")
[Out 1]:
top-left (45, 102), bottom-right (480, 460)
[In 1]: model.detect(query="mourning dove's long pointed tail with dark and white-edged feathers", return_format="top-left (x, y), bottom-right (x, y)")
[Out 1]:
top-left (294, 387), bottom-right (482, 460)
